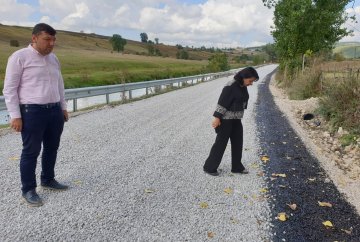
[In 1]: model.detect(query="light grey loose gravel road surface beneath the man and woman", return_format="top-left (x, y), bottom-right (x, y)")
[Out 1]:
top-left (0, 66), bottom-right (276, 241)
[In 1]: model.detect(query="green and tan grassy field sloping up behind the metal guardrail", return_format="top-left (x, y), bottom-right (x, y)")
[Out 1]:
top-left (0, 25), bottom-right (217, 94)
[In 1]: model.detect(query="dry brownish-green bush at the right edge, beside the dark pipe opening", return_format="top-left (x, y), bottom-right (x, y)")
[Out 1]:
top-left (319, 75), bottom-right (360, 135)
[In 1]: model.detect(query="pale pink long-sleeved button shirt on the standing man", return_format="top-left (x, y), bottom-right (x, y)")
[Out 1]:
top-left (3, 45), bottom-right (66, 119)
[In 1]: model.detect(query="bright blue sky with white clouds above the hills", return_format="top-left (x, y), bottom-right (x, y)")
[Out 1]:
top-left (0, 0), bottom-right (360, 48)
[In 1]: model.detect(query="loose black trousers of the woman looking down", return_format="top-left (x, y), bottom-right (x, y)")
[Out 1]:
top-left (204, 119), bottom-right (245, 172)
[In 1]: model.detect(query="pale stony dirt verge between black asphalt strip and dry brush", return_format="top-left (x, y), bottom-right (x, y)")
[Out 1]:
top-left (270, 76), bottom-right (360, 214)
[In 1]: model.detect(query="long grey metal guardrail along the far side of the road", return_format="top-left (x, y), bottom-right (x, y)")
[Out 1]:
top-left (0, 69), bottom-right (238, 112)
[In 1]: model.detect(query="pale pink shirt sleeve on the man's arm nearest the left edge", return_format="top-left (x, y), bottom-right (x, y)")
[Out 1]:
top-left (3, 55), bottom-right (23, 119)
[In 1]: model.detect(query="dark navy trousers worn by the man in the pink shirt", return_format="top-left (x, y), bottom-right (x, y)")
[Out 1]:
top-left (20, 104), bottom-right (64, 193)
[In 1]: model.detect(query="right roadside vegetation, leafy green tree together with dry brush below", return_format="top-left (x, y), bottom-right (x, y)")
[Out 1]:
top-left (263, 0), bottom-right (360, 140)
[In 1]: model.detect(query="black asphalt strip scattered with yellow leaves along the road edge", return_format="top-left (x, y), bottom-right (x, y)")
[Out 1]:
top-left (256, 69), bottom-right (360, 242)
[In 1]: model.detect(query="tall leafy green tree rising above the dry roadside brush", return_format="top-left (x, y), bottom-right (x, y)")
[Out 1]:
top-left (263, 0), bottom-right (354, 74)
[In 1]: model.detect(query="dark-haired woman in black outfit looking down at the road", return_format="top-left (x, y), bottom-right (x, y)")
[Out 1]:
top-left (204, 67), bottom-right (259, 176)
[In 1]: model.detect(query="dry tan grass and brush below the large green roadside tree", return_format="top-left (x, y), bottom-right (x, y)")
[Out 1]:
top-left (278, 59), bottom-right (360, 139)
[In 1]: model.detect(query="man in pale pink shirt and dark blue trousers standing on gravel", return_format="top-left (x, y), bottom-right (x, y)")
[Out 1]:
top-left (3, 23), bottom-right (68, 206)
